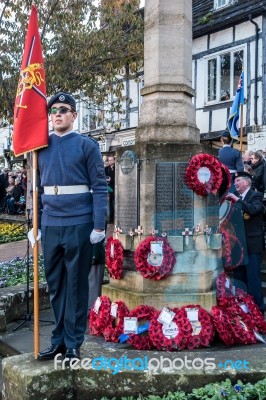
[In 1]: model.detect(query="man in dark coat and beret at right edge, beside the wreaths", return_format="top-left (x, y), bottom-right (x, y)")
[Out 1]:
top-left (228, 172), bottom-right (264, 313)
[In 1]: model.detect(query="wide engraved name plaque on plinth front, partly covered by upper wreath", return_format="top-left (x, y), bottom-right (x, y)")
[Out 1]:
top-left (155, 162), bottom-right (194, 235)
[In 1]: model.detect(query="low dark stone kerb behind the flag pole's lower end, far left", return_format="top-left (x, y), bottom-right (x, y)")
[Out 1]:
top-left (0, 283), bottom-right (50, 332)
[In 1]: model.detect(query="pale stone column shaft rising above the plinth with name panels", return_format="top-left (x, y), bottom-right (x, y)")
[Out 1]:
top-left (136, 0), bottom-right (199, 143)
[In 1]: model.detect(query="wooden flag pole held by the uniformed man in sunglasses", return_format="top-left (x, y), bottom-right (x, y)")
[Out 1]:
top-left (32, 150), bottom-right (40, 359)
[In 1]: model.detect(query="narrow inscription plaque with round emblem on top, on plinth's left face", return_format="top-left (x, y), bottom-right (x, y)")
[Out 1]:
top-left (116, 150), bottom-right (138, 234)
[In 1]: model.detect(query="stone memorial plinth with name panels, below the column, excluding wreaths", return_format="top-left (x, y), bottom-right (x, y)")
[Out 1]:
top-left (103, 143), bottom-right (222, 310)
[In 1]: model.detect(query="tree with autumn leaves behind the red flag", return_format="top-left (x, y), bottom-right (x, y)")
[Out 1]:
top-left (0, 0), bottom-right (143, 123)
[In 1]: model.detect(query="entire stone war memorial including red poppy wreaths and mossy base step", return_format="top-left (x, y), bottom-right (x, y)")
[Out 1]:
top-left (3, 0), bottom-right (266, 400)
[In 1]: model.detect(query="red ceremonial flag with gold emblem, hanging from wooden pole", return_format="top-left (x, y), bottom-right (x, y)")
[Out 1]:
top-left (13, 6), bottom-right (48, 156)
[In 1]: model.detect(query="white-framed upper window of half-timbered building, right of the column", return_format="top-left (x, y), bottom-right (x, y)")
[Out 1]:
top-left (207, 48), bottom-right (244, 103)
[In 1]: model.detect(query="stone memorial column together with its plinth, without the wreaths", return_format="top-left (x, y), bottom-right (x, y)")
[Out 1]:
top-left (103, 0), bottom-right (221, 309)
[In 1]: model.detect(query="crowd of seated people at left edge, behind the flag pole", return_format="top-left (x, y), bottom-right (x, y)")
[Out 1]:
top-left (0, 167), bottom-right (27, 215)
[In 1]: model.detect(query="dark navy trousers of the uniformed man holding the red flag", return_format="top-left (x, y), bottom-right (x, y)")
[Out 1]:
top-left (42, 224), bottom-right (93, 348)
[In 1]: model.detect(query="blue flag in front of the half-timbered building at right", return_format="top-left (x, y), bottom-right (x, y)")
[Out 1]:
top-left (227, 71), bottom-right (244, 139)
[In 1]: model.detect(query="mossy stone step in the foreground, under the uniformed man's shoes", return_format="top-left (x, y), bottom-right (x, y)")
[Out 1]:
top-left (3, 342), bottom-right (266, 400)
